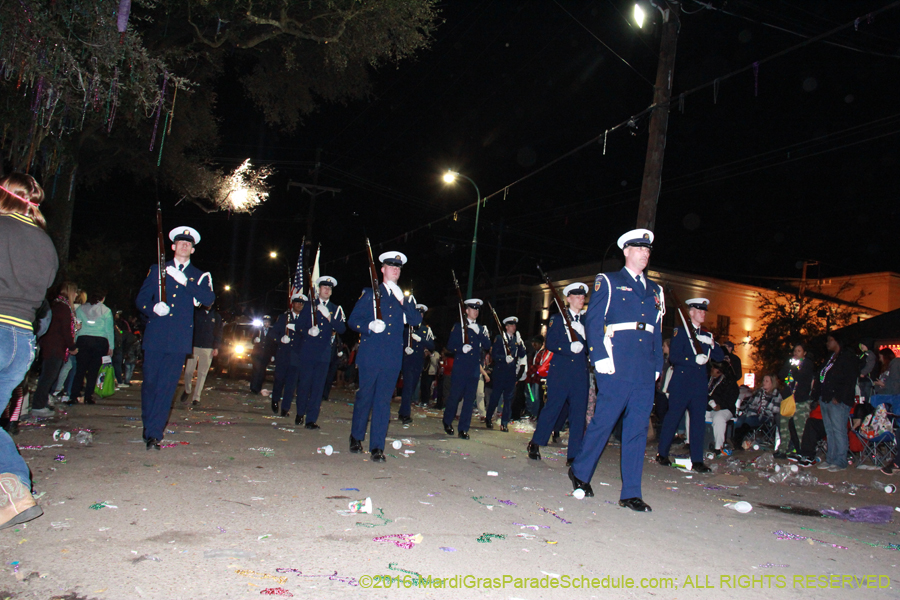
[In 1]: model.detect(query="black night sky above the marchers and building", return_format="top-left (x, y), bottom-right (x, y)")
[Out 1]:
top-left (72, 0), bottom-right (900, 312)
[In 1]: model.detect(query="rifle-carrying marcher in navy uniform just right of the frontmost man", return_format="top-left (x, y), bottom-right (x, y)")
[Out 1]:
top-left (656, 298), bottom-right (730, 473)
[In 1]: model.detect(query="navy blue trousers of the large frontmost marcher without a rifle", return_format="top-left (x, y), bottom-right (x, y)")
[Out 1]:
top-left (572, 375), bottom-right (656, 499)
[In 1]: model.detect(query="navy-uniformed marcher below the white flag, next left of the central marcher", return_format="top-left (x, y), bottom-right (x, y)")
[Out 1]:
top-left (294, 275), bottom-right (347, 429)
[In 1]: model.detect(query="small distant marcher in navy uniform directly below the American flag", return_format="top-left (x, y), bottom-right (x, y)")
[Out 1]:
top-left (271, 290), bottom-right (310, 417)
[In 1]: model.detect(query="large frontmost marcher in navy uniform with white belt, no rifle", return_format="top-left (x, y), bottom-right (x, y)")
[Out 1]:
top-left (569, 229), bottom-right (665, 512)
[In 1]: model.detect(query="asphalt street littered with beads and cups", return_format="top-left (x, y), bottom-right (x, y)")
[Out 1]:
top-left (0, 377), bottom-right (900, 600)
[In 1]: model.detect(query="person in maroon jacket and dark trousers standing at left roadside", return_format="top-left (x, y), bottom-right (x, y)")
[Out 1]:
top-left (31, 282), bottom-right (78, 417)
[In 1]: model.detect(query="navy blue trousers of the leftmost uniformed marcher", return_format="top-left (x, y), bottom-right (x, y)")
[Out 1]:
top-left (141, 351), bottom-right (186, 440)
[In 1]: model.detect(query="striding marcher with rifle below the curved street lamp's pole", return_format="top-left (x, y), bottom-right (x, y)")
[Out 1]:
top-left (444, 298), bottom-right (491, 440)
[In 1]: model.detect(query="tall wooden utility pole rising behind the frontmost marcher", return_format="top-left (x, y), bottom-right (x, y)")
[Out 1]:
top-left (637, 1), bottom-right (681, 231)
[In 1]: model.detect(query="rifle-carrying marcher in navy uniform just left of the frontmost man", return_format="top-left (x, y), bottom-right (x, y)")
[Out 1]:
top-left (528, 283), bottom-right (590, 467)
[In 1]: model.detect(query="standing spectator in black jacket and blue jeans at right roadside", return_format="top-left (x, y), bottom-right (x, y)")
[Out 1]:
top-left (818, 333), bottom-right (859, 472)
